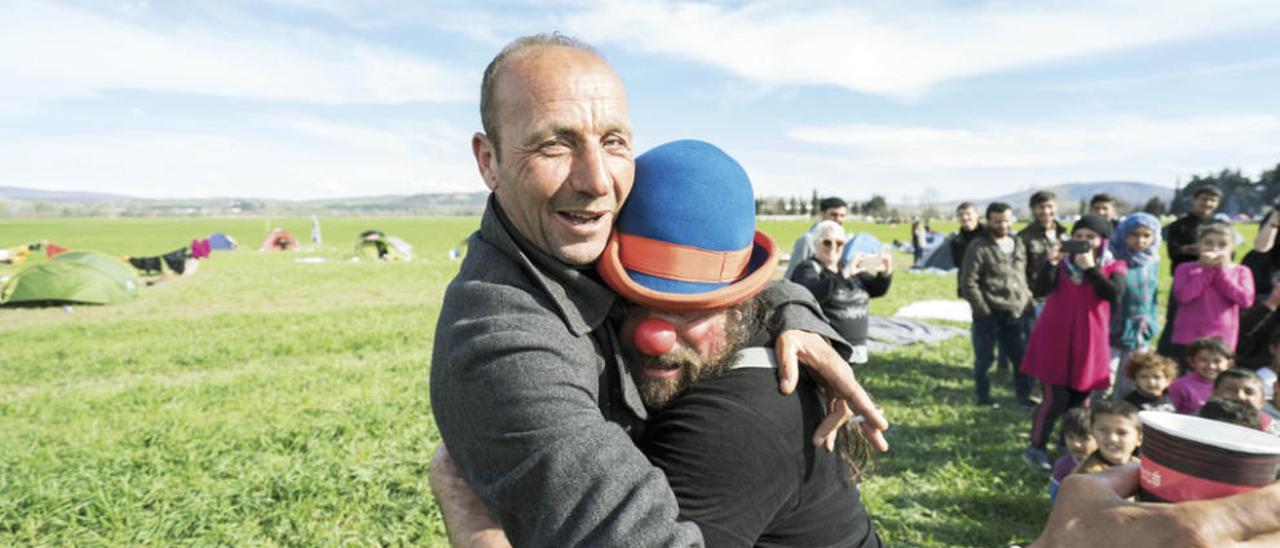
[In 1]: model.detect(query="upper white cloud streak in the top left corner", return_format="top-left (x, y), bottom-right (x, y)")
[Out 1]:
top-left (0, 3), bottom-right (480, 104)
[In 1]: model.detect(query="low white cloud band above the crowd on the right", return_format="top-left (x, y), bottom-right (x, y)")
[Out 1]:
top-left (744, 114), bottom-right (1280, 201)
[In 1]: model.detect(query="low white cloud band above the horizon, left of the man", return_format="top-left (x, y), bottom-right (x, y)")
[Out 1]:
top-left (0, 118), bottom-right (484, 198)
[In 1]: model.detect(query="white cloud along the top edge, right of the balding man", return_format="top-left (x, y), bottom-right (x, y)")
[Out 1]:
top-left (566, 0), bottom-right (1280, 99)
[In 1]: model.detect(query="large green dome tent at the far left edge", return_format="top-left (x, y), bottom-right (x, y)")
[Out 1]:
top-left (0, 252), bottom-right (138, 305)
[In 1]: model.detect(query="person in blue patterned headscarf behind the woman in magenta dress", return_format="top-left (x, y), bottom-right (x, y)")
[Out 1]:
top-left (1110, 213), bottom-right (1160, 398)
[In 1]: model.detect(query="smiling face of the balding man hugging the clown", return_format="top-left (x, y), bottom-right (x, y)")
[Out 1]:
top-left (472, 46), bottom-right (635, 265)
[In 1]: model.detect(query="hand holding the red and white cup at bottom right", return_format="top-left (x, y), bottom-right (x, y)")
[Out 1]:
top-left (1030, 462), bottom-right (1280, 548)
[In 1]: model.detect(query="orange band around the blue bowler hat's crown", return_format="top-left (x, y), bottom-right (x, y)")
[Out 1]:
top-left (617, 233), bottom-right (751, 283)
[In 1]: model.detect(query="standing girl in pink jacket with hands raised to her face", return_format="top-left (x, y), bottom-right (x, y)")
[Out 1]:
top-left (1172, 223), bottom-right (1253, 359)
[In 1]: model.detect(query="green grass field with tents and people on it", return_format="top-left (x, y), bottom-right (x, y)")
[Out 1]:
top-left (0, 218), bottom-right (1252, 545)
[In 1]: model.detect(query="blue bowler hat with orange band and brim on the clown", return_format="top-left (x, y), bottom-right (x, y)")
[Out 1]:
top-left (596, 141), bottom-right (778, 311)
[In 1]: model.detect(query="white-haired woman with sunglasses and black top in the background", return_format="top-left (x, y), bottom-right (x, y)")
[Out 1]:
top-left (791, 220), bottom-right (893, 364)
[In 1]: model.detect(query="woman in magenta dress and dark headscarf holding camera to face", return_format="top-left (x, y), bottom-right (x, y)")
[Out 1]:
top-left (1021, 214), bottom-right (1128, 472)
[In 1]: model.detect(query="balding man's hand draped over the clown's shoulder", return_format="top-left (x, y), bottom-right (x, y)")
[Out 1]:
top-left (776, 329), bottom-right (888, 452)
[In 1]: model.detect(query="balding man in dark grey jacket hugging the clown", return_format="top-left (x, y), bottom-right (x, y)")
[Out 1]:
top-left (430, 35), bottom-right (886, 545)
